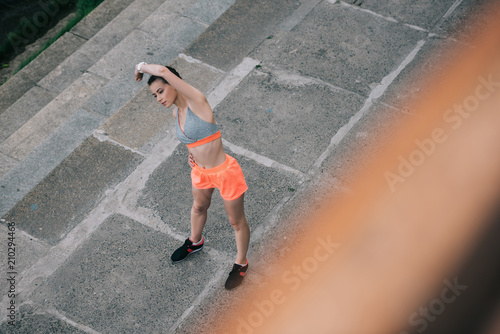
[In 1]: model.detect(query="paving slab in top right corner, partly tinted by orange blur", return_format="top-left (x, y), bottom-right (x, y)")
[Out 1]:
top-left (432, 0), bottom-right (496, 45)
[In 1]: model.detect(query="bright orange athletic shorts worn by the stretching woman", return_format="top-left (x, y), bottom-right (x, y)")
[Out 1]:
top-left (191, 154), bottom-right (248, 201)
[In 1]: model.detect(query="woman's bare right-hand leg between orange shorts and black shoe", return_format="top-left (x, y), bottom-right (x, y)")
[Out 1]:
top-left (224, 194), bottom-right (250, 264)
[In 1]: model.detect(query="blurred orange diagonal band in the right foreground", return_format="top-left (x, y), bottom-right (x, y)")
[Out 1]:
top-left (224, 2), bottom-right (500, 334)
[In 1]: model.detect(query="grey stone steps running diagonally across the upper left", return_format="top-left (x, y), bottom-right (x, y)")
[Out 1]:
top-left (0, 0), bottom-right (234, 216)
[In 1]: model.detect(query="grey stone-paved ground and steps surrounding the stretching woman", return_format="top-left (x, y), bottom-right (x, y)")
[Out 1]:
top-left (0, 0), bottom-right (492, 334)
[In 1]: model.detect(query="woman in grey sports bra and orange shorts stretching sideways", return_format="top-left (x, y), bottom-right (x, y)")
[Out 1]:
top-left (135, 62), bottom-right (250, 290)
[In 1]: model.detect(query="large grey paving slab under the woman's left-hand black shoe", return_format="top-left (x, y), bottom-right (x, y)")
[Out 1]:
top-left (29, 215), bottom-right (222, 333)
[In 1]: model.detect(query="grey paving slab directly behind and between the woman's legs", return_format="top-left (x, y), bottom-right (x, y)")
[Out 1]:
top-left (138, 145), bottom-right (300, 256)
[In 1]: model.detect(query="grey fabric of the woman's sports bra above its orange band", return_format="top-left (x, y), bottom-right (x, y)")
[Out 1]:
top-left (175, 106), bottom-right (219, 144)
